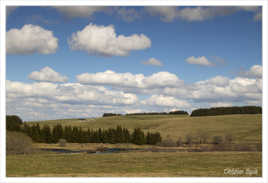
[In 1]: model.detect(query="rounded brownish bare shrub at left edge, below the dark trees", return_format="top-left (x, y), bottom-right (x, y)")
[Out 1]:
top-left (6, 131), bottom-right (33, 154)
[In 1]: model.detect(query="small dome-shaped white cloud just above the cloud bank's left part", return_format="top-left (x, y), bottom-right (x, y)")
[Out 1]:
top-left (28, 67), bottom-right (68, 82)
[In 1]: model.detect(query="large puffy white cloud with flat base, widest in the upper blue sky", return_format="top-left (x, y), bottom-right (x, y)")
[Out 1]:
top-left (68, 24), bottom-right (151, 56)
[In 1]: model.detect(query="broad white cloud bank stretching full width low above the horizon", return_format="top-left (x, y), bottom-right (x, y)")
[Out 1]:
top-left (6, 65), bottom-right (262, 119)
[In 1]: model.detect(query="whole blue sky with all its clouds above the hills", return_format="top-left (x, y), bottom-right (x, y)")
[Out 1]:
top-left (6, 6), bottom-right (262, 121)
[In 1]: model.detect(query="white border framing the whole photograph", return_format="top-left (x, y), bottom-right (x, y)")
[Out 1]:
top-left (0, 0), bottom-right (268, 183)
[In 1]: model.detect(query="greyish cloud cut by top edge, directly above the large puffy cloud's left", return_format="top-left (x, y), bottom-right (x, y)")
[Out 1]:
top-left (54, 6), bottom-right (107, 18)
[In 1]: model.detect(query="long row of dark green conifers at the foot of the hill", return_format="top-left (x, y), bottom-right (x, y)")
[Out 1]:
top-left (21, 124), bottom-right (162, 145)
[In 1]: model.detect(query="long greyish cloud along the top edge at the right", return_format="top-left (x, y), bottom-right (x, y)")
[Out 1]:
top-left (145, 6), bottom-right (258, 22)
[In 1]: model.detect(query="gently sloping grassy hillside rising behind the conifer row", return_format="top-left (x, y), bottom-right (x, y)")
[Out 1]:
top-left (27, 114), bottom-right (262, 143)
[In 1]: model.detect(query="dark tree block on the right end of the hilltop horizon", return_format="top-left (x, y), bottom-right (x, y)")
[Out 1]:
top-left (191, 106), bottom-right (262, 116)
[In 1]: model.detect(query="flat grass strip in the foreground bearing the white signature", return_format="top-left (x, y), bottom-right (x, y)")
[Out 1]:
top-left (7, 152), bottom-right (262, 177)
